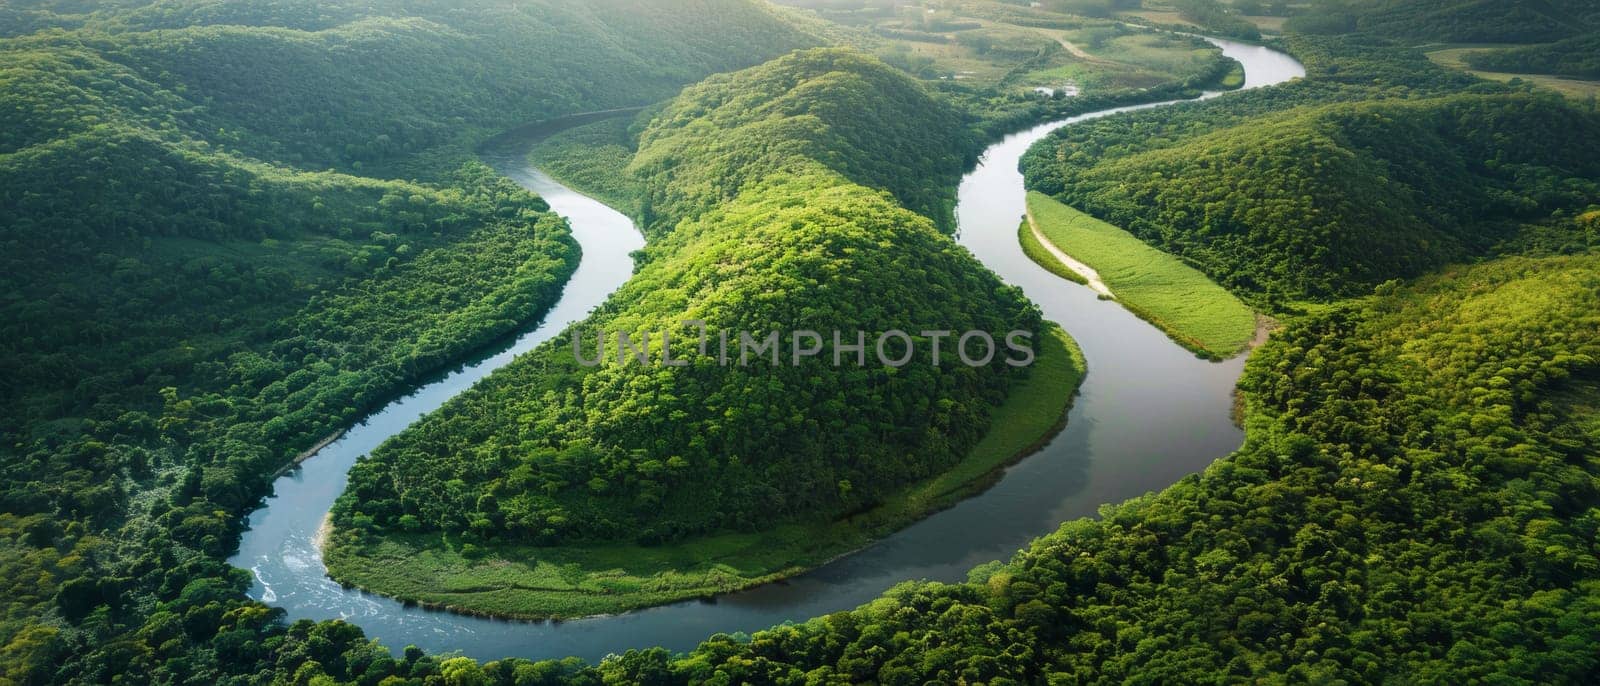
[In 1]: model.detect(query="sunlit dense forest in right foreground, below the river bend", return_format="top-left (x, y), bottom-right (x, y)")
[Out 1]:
top-left (528, 256), bottom-right (1600, 684)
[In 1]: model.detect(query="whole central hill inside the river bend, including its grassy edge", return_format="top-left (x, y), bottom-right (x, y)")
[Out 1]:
top-left (328, 50), bottom-right (1082, 617)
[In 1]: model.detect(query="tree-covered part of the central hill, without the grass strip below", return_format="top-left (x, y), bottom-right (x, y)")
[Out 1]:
top-left (334, 50), bottom-right (1040, 550)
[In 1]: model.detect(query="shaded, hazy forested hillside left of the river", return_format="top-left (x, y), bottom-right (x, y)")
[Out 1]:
top-left (0, 0), bottom-right (814, 683)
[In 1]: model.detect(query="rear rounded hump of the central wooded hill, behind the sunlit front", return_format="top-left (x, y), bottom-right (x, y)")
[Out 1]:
top-left (629, 50), bottom-right (979, 232)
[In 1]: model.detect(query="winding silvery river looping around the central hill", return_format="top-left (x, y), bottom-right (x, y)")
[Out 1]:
top-left (230, 40), bottom-right (1304, 660)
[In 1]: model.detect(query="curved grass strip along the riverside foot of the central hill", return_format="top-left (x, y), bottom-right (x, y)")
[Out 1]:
top-left (325, 326), bottom-right (1085, 619)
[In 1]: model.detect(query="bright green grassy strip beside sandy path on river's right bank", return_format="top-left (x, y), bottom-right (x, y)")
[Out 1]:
top-left (1027, 192), bottom-right (1256, 358)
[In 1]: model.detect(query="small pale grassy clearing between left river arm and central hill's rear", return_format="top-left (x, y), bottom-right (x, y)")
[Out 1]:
top-left (528, 114), bottom-right (643, 216)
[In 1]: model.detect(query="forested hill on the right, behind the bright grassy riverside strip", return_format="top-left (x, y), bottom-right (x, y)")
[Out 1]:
top-left (1024, 42), bottom-right (1600, 301)
